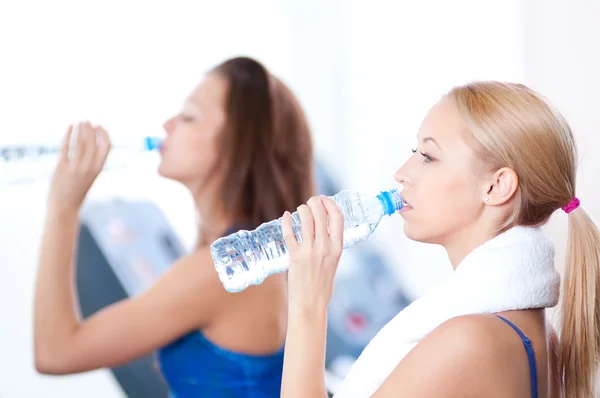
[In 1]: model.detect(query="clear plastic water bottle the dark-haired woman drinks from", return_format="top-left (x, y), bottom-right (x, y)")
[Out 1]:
top-left (0, 137), bottom-right (162, 185)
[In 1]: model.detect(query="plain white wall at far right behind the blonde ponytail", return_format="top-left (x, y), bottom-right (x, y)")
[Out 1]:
top-left (524, 0), bottom-right (600, 320)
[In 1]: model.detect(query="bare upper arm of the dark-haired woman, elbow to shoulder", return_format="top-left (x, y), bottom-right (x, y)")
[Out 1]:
top-left (58, 250), bottom-right (226, 373)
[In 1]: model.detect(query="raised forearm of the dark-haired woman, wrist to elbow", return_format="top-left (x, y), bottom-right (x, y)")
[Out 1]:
top-left (34, 209), bottom-right (79, 361)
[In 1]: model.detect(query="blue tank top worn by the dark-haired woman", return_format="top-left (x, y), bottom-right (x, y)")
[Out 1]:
top-left (158, 228), bottom-right (284, 398)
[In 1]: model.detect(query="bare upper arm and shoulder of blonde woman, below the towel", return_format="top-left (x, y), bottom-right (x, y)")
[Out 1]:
top-left (373, 315), bottom-right (504, 398)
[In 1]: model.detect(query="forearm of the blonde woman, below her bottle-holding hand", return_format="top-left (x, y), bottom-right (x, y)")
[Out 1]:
top-left (281, 310), bottom-right (327, 398)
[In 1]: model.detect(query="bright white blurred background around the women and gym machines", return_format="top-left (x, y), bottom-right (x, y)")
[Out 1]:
top-left (0, 0), bottom-right (600, 398)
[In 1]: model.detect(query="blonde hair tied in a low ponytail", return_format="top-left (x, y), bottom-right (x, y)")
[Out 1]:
top-left (447, 82), bottom-right (600, 398)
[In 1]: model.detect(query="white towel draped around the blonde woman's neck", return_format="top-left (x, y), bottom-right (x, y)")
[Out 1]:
top-left (335, 227), bottom-right (560, 398)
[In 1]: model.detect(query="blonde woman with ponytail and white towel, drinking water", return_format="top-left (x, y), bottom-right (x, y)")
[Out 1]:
top-left (282, 82), bottom-right (600, 398)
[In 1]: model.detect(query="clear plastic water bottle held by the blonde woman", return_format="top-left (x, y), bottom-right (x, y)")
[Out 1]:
top-left (210, 189), bottom-right (404, 293)
